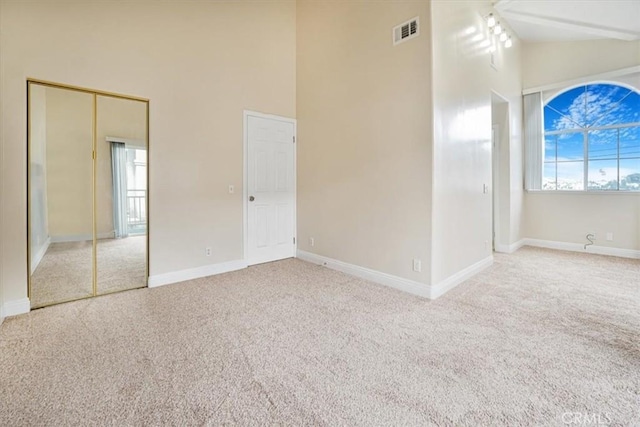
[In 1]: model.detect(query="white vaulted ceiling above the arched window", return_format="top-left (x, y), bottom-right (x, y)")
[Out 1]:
top-left (494, 0), bottom-right (640, 42)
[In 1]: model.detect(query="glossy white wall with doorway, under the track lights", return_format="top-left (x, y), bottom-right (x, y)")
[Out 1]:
top-left (431, 1), bottom-right (522, 284)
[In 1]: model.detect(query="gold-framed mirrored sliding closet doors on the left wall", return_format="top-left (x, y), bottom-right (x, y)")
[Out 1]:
top-left (28, 81), bottom-right (149, 308)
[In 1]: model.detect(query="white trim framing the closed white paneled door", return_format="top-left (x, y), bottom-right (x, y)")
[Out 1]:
top-left (242, 110), bottom-right (298, 265)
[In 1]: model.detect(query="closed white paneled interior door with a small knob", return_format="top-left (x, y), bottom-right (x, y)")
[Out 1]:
top-left (246, 115), bottom-right (296, 265)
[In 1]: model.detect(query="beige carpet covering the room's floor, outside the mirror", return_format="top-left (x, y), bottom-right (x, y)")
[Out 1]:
top-left (0, 248), bottom-right (640, 426)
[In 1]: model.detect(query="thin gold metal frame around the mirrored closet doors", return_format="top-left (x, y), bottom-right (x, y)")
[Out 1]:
top-left (27, 78), bottom-right (151, 309)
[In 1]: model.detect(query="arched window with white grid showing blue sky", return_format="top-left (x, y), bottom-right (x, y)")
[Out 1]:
top-left (542, 83), bottom-right (640, 191)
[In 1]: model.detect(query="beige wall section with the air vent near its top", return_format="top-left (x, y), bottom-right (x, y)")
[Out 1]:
top-left (297, 1), bottom-right (431, 289)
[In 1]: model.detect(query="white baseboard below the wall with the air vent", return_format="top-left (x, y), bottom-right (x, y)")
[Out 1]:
top-left (296, 249), bottom-right (430, 298)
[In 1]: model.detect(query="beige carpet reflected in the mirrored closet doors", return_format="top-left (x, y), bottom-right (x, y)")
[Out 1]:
top-left (31, 236), bottom-right (147, 307)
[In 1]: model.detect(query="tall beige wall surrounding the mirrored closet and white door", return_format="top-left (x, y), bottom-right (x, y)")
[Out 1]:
top-left (0, 0), bottom-right (296, 304)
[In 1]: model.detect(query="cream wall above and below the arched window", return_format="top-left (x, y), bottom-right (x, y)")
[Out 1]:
top-left (523, 40), bottom-right (640, 251)
